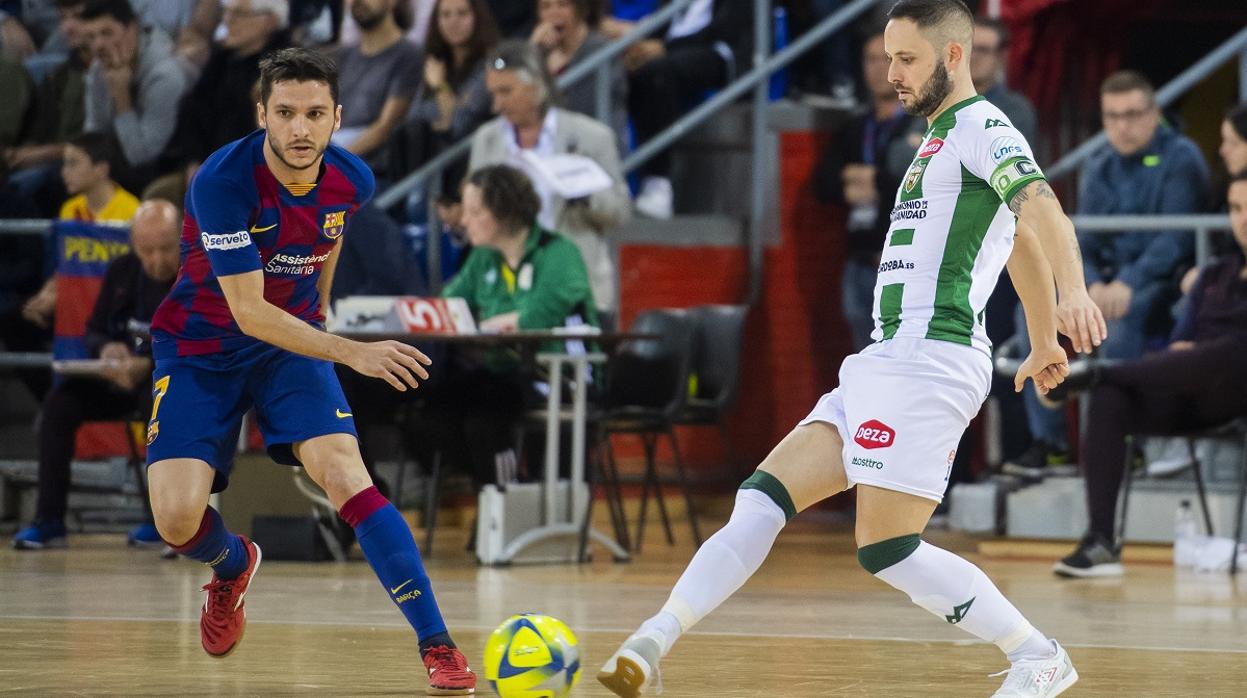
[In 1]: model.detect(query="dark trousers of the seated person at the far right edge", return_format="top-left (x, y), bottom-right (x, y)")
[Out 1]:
top-left (1082, 337), bottom-right (1247, 540)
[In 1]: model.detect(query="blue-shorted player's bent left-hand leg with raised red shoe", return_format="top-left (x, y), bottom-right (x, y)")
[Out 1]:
top-left (147, 459), bottom-right (261, 657)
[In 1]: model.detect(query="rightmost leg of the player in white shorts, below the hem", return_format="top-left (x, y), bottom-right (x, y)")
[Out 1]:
top-left (857, 485), bottom-right (1077, 697)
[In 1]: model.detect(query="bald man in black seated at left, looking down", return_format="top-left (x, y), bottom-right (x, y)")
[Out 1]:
top-left (12, 201), bottom-right (182, 550)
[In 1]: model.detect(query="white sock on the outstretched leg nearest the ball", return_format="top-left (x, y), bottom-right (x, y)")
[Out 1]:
top-left (637, 490), bottom-right (788, 656)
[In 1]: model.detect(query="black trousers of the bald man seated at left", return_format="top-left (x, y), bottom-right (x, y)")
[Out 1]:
top-left (35, 378), bottom-right (151, 521)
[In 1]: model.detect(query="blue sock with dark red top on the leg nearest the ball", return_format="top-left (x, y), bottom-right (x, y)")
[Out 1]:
top-left (338, 487), bottom-right (454, 649)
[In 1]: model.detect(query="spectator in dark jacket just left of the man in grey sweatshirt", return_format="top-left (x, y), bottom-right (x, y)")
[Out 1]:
top-left (0, 0), bottom-right (91, 218)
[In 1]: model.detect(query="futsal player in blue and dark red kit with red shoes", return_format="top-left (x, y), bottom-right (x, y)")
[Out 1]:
top-left (147, 49), bottom-right (476, 696)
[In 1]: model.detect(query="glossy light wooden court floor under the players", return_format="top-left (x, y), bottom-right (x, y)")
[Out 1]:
top-left (0, 521), bottom-right (1247, 698)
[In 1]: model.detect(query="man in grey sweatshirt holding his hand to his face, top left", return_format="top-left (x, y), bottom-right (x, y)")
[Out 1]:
top-left (82, 0), bottom-right (188, 191)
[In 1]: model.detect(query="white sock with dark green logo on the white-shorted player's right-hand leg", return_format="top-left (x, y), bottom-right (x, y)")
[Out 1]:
top-left (875, 542), bottom-right (1054, 661)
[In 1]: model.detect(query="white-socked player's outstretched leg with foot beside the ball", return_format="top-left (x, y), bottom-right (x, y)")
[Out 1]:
top-left (597, 423), bottom-right (847, 698)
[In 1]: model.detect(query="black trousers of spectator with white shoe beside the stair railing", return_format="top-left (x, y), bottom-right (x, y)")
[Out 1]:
top-left (627, 46), bottom-right (727, 177)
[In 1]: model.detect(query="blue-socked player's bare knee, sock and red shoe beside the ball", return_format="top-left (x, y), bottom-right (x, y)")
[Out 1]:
top-left (294, 434), bottom-right (476, 696)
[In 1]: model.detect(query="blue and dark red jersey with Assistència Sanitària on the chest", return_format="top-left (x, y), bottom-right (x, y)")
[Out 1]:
top-left (152, 131), bottom-right (374, 359)
